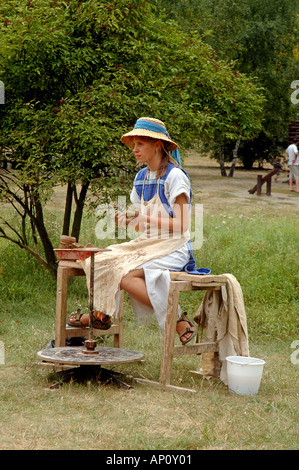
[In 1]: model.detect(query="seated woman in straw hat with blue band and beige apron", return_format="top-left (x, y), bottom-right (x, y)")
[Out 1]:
top-left (69, 118), bottom-right (196, 344)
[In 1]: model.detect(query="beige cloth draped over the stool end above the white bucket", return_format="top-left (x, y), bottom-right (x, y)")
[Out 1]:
top-left (195, 274), bottom-right (249, 384)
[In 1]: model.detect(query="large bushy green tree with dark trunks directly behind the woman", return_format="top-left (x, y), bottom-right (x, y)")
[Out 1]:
top-left (0, 0), bottom-right (263, 273)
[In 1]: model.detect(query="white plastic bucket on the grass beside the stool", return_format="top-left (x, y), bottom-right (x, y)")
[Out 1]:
top-left (226, 356), bottom-right (265, 395)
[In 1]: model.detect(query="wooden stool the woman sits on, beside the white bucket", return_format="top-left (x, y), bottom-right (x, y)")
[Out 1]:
top-left (159, 272), bottom-right (227, 389)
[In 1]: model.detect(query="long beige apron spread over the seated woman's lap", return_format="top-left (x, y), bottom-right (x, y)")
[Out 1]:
top-left (80, 191), bottom-right (190, 316)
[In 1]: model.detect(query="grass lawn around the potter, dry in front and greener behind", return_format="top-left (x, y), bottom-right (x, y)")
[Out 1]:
top-left (0, 214), bottom-right (299, 450)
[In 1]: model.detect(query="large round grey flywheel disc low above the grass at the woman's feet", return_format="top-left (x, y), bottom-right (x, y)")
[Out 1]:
top-left (37, 346), bottom-right (143, 365)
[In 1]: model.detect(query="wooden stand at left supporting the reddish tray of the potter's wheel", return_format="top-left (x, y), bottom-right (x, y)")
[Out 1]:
top-left (55, 261), bottom-right (124, 348)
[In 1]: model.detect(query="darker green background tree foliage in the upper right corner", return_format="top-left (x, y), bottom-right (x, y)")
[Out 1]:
top-left (157, 0), bottom-right (299, 168)
